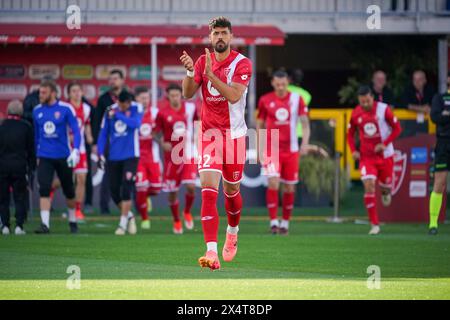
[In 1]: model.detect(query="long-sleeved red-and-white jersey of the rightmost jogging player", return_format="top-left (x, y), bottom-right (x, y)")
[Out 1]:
top-left (347, 101), bottom-right (401, 160)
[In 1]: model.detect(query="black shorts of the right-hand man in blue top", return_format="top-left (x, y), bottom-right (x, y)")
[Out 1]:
top-left (106, 158), bottom-right (139, 205)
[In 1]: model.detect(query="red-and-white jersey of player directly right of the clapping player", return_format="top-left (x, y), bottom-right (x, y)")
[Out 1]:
top-left (258, 92), bottom-right (308, 152)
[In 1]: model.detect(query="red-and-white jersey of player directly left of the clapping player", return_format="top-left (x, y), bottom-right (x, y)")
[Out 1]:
top-left (154, 102), bottom-right (197, 158)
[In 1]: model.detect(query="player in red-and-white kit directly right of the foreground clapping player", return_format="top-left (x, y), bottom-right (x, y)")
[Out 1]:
top-left (257, 71), bottom-right (310, 235)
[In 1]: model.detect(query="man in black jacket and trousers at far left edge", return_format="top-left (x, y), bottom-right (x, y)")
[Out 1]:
top-left (0, 100), bottom-right (36, 235)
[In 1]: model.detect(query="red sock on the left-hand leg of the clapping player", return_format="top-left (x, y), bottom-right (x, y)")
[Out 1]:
top-left (201, 188), bottom-right (219, 243)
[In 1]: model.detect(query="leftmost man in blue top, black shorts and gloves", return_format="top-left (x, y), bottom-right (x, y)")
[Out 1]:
top-left (33, 80), bottom-right (81, 234)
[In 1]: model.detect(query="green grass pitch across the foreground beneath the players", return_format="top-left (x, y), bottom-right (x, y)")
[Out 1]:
top-left (0, 210), bottom-right (450, 300)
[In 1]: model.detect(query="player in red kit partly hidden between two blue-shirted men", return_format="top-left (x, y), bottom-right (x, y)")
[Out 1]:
top-left (67, 82), bottom-right (94, 220)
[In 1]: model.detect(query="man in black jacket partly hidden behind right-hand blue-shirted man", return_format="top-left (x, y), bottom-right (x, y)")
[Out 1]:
top-left (91, 69), bottom-right (125, 214)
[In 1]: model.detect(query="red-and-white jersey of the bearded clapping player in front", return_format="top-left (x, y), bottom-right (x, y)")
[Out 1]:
top-left (194, 50), bottom-right (252, 139)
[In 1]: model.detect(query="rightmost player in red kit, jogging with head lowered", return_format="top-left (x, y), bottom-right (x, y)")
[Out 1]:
top-left (347, 86), bottom-right (401, 235)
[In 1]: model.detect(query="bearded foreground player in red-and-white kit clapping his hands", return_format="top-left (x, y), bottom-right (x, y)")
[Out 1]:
top-left (180, 17), bottom-right (252, 270)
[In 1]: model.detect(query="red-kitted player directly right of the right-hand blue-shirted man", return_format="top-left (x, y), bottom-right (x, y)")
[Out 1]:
top-left (134, 87), bottom-right (162, 229)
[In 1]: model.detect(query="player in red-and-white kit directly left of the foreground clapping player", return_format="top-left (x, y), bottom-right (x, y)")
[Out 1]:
top-left (154, 84), bottom-right (197, 234)
